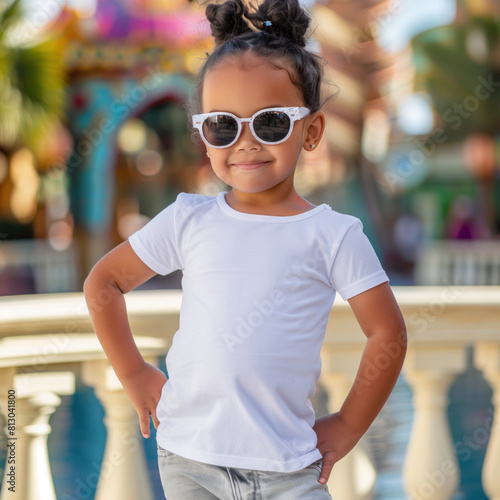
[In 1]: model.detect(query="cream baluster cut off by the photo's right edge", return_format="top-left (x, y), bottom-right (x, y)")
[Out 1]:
top-left (474, 342), bottom-right (500, 500)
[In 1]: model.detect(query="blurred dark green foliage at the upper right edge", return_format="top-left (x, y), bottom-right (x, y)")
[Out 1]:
top-left (412, 17), bottom-right (500, 141)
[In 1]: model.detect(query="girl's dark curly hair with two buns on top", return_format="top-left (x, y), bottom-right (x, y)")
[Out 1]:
top-left (190, 0), bottom-right (326, 119)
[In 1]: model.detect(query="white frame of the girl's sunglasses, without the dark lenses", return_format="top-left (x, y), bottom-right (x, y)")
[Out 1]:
top-left (193, 107), bottom-right (311, 149)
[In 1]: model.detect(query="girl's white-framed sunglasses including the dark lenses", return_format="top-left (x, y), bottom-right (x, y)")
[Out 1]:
top-left (193, 107), bottom-right (311, 149)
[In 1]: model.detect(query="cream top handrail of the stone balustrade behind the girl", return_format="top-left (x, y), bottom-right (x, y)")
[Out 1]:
top-left (0, 285), bottom-right (500, 342)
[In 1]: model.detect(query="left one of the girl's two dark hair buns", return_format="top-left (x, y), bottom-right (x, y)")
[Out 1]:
top-left (205, 0), bottom-right (251, 46)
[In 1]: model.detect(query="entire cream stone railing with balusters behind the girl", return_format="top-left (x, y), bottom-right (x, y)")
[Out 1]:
top-left (0, 287), bottom-right (500, 500)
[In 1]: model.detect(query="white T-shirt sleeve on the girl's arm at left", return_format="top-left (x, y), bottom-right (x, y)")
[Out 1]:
top-left (128, 197), bottom-right (182, 275)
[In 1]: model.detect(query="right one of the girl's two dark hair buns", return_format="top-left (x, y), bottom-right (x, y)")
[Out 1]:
top-left (246, 0), bottom-right (311, 47)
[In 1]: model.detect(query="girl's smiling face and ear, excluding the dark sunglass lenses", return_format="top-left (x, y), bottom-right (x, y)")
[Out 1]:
top-left (202, 53), bottom-right (324, 194)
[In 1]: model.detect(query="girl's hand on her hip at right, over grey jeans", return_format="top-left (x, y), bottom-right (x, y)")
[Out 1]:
top-left (313, 413), bottom-right (361, 484)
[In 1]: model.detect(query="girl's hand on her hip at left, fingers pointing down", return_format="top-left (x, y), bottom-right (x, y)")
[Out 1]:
top-left (121, 363), bottom-right (168, 438)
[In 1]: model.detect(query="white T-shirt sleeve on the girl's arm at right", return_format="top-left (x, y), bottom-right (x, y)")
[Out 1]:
top-left (330, 220), bottom-right (389, 300)
